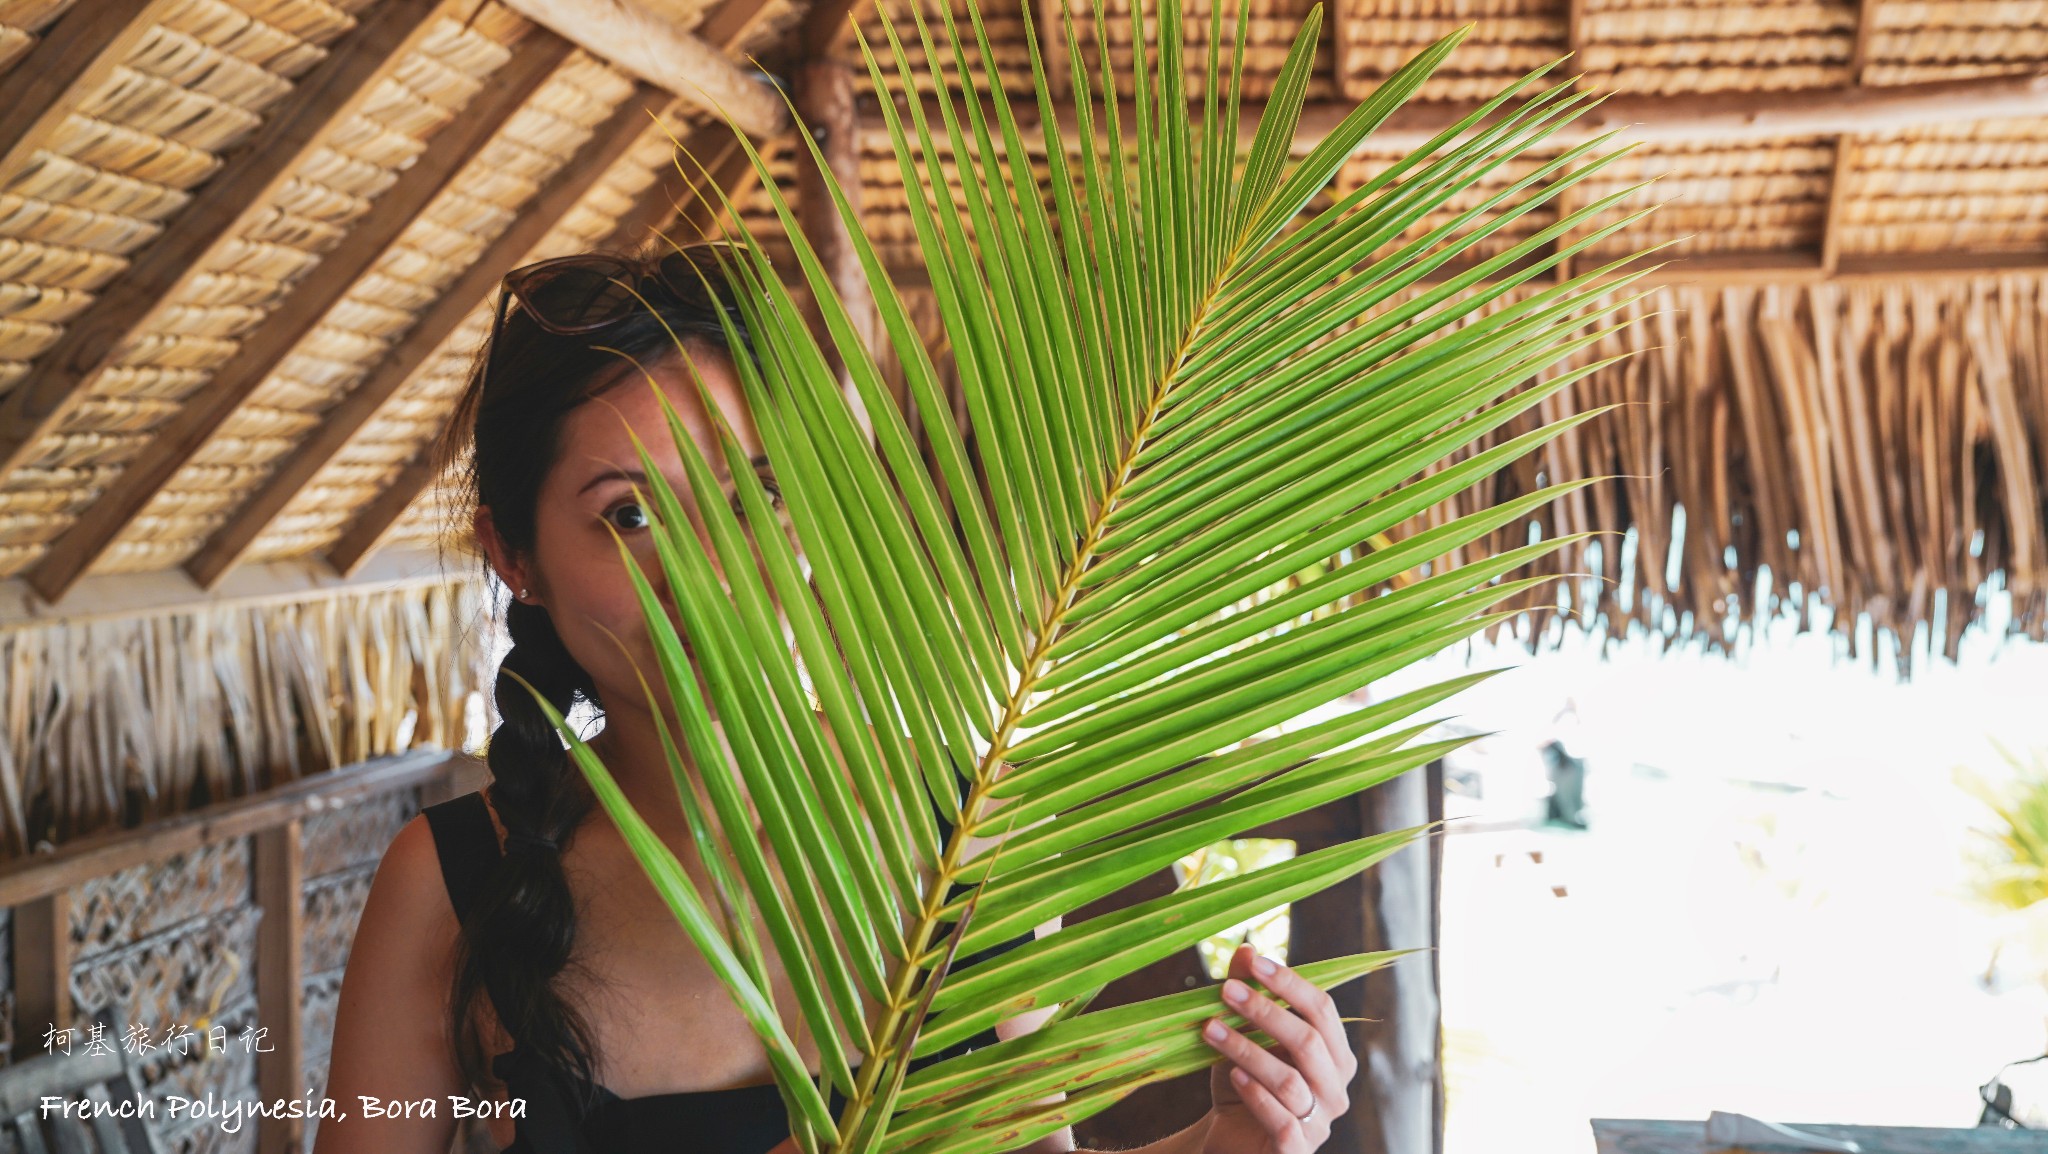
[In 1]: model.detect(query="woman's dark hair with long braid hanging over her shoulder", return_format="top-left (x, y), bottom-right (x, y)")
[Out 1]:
top-left (434, 241), bottom-right (752, 1109)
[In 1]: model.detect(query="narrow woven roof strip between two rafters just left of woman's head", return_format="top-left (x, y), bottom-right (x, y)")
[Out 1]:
top-left (296, 110), bottom-right (688, 558)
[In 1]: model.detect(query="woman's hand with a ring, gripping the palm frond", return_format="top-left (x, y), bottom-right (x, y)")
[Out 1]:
top-left (1202, 945), bottom-right (1358, 1154)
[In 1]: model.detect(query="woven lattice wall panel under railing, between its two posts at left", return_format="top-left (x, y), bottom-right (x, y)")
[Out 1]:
top-left (72, 838), bottom-right (250, 959)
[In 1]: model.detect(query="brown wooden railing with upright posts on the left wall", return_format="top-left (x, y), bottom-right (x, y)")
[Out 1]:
top-left (0, 750), bottom-right (485, 1154)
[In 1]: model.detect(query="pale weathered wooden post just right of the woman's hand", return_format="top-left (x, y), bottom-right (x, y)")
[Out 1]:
top-left (1354, 771), bottom-right (1444, 1154)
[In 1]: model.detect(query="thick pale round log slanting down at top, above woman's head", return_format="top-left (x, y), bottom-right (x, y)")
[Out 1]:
top-left (504, 0), bottom-right (788, 137)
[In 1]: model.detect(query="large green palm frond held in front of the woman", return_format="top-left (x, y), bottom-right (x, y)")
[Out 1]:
top-left (524, 0), bottom-right (1640, 1154)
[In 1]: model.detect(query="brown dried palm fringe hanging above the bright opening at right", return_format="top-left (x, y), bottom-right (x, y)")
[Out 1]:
top-left (1395, 277), bottom-right (2048, 676)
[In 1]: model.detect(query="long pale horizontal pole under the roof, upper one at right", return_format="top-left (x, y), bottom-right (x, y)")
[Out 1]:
top-left (1011, 74), bottom-right (2048, 152)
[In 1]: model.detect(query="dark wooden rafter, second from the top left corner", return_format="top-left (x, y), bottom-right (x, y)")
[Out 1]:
top-left (0, 0), bottom-right (462, 476)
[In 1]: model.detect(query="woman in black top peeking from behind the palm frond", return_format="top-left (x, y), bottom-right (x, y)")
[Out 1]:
top-left (315, 248), bottom-right (1356, 1154)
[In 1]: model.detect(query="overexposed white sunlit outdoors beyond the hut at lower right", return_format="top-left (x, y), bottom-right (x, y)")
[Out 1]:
top-left (1374, 606), bottom-right (2048, 1154)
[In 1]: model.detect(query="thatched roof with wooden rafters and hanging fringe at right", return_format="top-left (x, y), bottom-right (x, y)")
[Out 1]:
top-left (0, 0), bottom-right (2048, 668)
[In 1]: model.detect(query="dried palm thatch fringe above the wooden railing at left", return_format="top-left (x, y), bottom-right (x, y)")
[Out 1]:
top-left (0, 582), bottom-right (487, 857)
